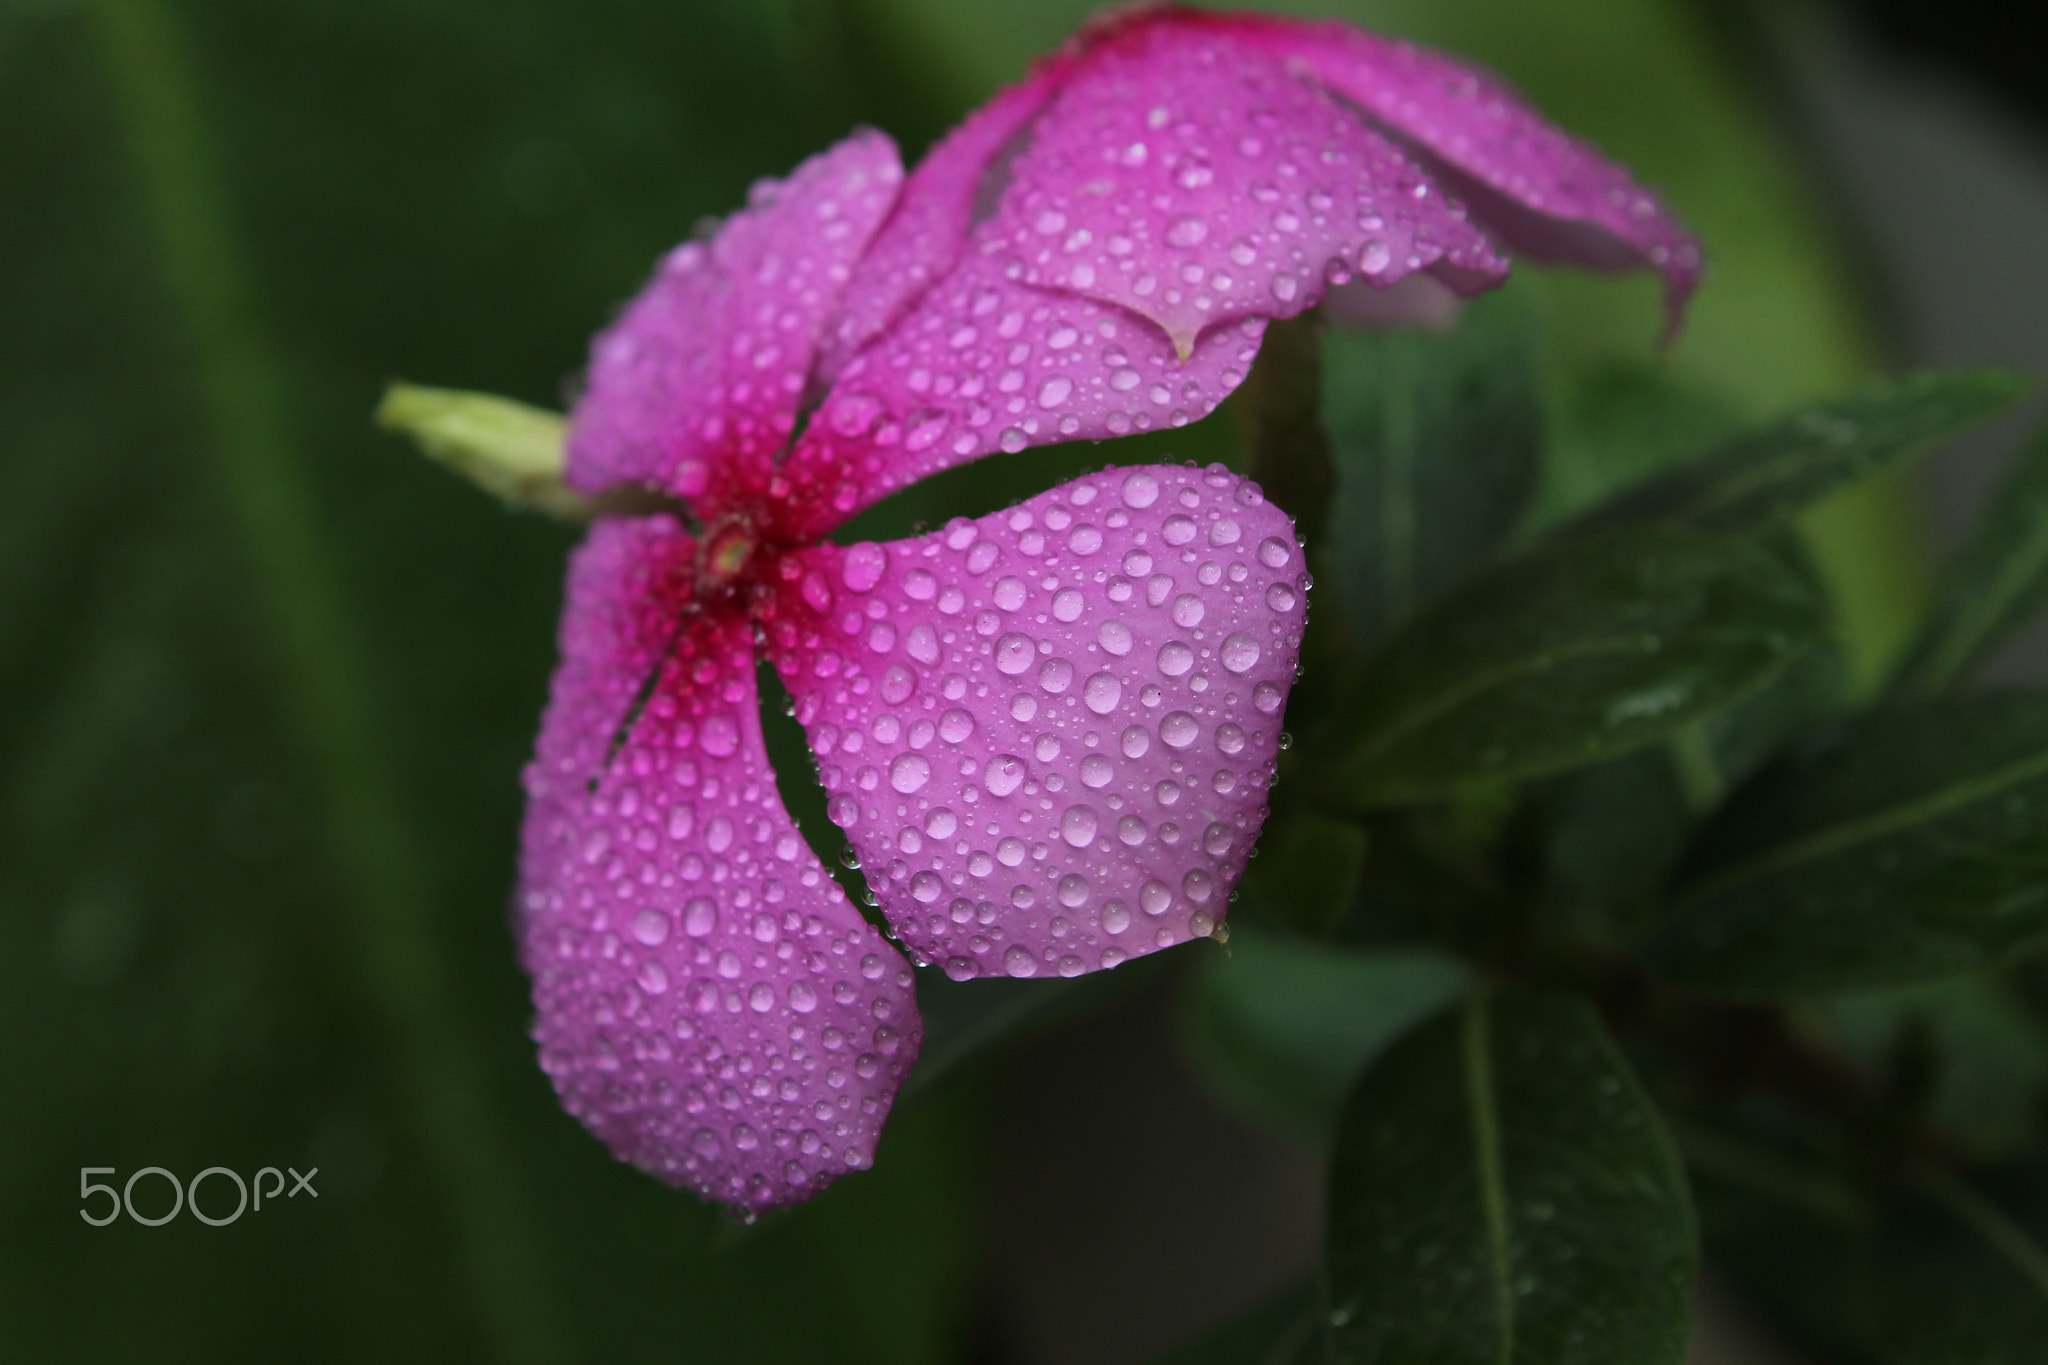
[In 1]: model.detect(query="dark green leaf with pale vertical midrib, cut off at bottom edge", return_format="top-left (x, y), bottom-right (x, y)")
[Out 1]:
top-left (1325, 990), bottom-right (1698, 1365)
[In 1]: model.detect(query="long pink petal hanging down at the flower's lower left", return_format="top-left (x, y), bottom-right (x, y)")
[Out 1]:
top-left (518, 518), bottom-right (922, 1209)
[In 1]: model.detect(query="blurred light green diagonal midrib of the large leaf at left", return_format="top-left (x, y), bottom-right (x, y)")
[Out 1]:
top-left (92, 0), bottom-right (567, 1365)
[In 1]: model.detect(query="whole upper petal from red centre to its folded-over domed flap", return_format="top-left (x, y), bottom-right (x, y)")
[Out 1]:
top-left (784, 12), bottom-right (1507, 534)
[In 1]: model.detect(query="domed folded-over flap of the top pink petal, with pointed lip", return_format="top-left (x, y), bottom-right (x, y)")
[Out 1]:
top-left (983, 12), bottom-right (1507, 354)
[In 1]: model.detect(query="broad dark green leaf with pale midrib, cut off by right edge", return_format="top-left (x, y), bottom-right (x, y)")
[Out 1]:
top-left (1649, 692), bottom-right (2048, 995)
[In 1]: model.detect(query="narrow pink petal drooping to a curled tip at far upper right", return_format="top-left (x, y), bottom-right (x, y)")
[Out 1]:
top-left (1204, 14), bottom-right (1700, 332)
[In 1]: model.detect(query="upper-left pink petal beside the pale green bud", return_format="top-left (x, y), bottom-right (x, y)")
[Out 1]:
top-left (567, 131), bottom-right (903, 520)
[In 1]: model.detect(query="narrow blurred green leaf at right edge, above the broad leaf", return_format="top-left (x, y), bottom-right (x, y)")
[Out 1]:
top-left (1892, 419), bottom-right (2048, 698)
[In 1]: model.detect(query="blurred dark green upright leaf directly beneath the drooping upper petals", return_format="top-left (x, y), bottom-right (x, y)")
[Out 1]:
top-left (1323, 293), bottom-right (1542, 643)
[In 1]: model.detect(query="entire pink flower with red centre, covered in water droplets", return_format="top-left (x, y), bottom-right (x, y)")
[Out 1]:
top-left (518, 8), bottom-right (1698, 1209)
